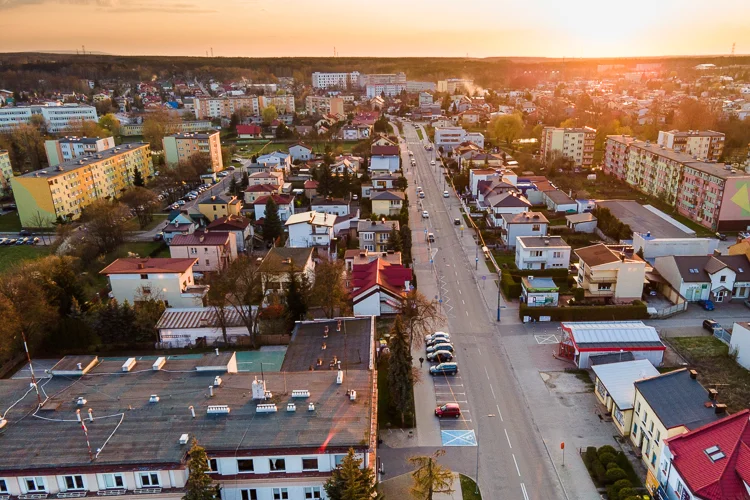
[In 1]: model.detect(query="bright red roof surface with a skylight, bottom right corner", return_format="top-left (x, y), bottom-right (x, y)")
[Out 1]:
top-left (666, 409), bottom-right (750, 500)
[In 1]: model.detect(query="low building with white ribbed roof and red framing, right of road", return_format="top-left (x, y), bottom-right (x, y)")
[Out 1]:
top-left (558, 321), bottom-right (666, 368)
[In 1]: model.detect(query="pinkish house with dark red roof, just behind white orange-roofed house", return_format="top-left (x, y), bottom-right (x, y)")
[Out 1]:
top-left (169, 231), bottom-right (237, 272)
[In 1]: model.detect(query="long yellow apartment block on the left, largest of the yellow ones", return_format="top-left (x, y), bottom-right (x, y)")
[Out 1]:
top-left (11, 143), bottom-right (154, 227)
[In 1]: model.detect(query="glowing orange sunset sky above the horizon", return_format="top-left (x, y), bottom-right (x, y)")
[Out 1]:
top-left (0, 0), bottom-right (750, 58)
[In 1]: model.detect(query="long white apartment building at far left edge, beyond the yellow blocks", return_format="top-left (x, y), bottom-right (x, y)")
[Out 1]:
top-left (0, 103), bottom-right (99, 134)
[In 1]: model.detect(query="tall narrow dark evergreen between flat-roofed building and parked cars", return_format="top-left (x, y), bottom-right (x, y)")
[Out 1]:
top-left (388, 315), bottom-right (414, 425)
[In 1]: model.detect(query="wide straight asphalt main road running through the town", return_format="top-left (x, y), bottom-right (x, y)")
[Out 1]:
top-left (404, 124), bottom-right (565, 500)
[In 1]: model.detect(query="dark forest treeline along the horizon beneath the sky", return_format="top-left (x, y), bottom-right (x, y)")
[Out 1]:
top-left (0, 53), bottom-right (750, 90)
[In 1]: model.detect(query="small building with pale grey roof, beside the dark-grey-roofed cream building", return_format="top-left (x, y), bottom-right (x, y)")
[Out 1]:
top-left (591, 360), bottom-right (659, 436)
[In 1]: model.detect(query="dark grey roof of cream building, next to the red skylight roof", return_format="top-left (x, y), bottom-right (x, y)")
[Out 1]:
top-left (635, 368), bottom-right (718, 429)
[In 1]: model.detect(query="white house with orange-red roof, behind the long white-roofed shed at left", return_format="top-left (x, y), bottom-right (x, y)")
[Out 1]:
top-left (99, 258), bottom-right (208, 307)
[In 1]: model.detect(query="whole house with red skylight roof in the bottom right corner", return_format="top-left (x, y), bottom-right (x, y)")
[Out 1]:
top-left (657, 408), bottom-right (750, 500)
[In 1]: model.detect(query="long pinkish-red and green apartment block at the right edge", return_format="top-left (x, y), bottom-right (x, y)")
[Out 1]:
top-left (603, 136), bottom-right (750, 231)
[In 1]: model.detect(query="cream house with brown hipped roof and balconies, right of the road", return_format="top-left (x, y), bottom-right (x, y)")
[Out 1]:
top-left (575, 243), bottom-right (646, 302)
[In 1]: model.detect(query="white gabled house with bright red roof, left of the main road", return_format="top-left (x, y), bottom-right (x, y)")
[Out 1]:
top-left (349, 258), bottom-right (413, 316)
